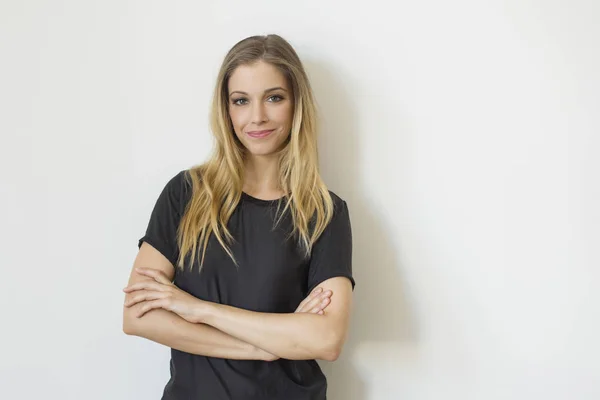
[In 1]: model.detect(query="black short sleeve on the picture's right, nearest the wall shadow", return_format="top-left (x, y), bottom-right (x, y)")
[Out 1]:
top-left (308, 194), bottom-right (355, 293)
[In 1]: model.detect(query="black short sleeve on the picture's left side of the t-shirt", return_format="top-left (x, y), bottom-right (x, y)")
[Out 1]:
top-left (138, 171), bottom-right (185, 266)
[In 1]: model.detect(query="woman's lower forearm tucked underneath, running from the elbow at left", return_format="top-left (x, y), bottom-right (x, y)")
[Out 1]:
top-left (123, 304), bottom-right (276, 361)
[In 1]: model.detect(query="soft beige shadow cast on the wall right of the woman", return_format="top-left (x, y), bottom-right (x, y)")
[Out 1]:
top-left (304, 60), bottom-right (417, 400)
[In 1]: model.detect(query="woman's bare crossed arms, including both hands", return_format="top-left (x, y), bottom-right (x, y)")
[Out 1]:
top-left (123, 243), bottom-right (352, 361)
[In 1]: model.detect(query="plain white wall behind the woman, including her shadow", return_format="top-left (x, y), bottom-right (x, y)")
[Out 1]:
top-left (0, 0), bottom-right (600, 400)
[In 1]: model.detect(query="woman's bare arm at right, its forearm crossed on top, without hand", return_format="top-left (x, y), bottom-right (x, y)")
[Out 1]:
top-left (198, 277), bottom-right (352, 361)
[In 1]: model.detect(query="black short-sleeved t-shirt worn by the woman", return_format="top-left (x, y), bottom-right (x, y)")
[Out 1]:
top-left (138, 171), bottom-right (355, 400)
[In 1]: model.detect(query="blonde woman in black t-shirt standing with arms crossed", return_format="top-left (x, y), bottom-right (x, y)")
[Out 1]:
top-left (123, 35), bottom-right (354, 400)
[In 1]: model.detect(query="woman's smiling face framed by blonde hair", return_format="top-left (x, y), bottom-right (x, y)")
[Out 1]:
top-left (228, 61), bottom-right (294, 156)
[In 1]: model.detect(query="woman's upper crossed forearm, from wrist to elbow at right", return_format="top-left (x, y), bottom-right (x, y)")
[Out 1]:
top-left (201, 302), bottom-right (344, 361)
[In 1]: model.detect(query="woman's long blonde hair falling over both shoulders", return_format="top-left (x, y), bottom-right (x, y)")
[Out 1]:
top-left (177, 35), bottom-right (333, 268)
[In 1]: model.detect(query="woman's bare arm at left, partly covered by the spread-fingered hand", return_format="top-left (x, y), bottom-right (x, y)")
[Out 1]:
top-left (123, 242), bottom-right (277, 361)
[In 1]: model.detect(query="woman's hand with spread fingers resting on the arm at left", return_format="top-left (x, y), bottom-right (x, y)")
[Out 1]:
top-left (123, 268), bottom-right (204, 324)
